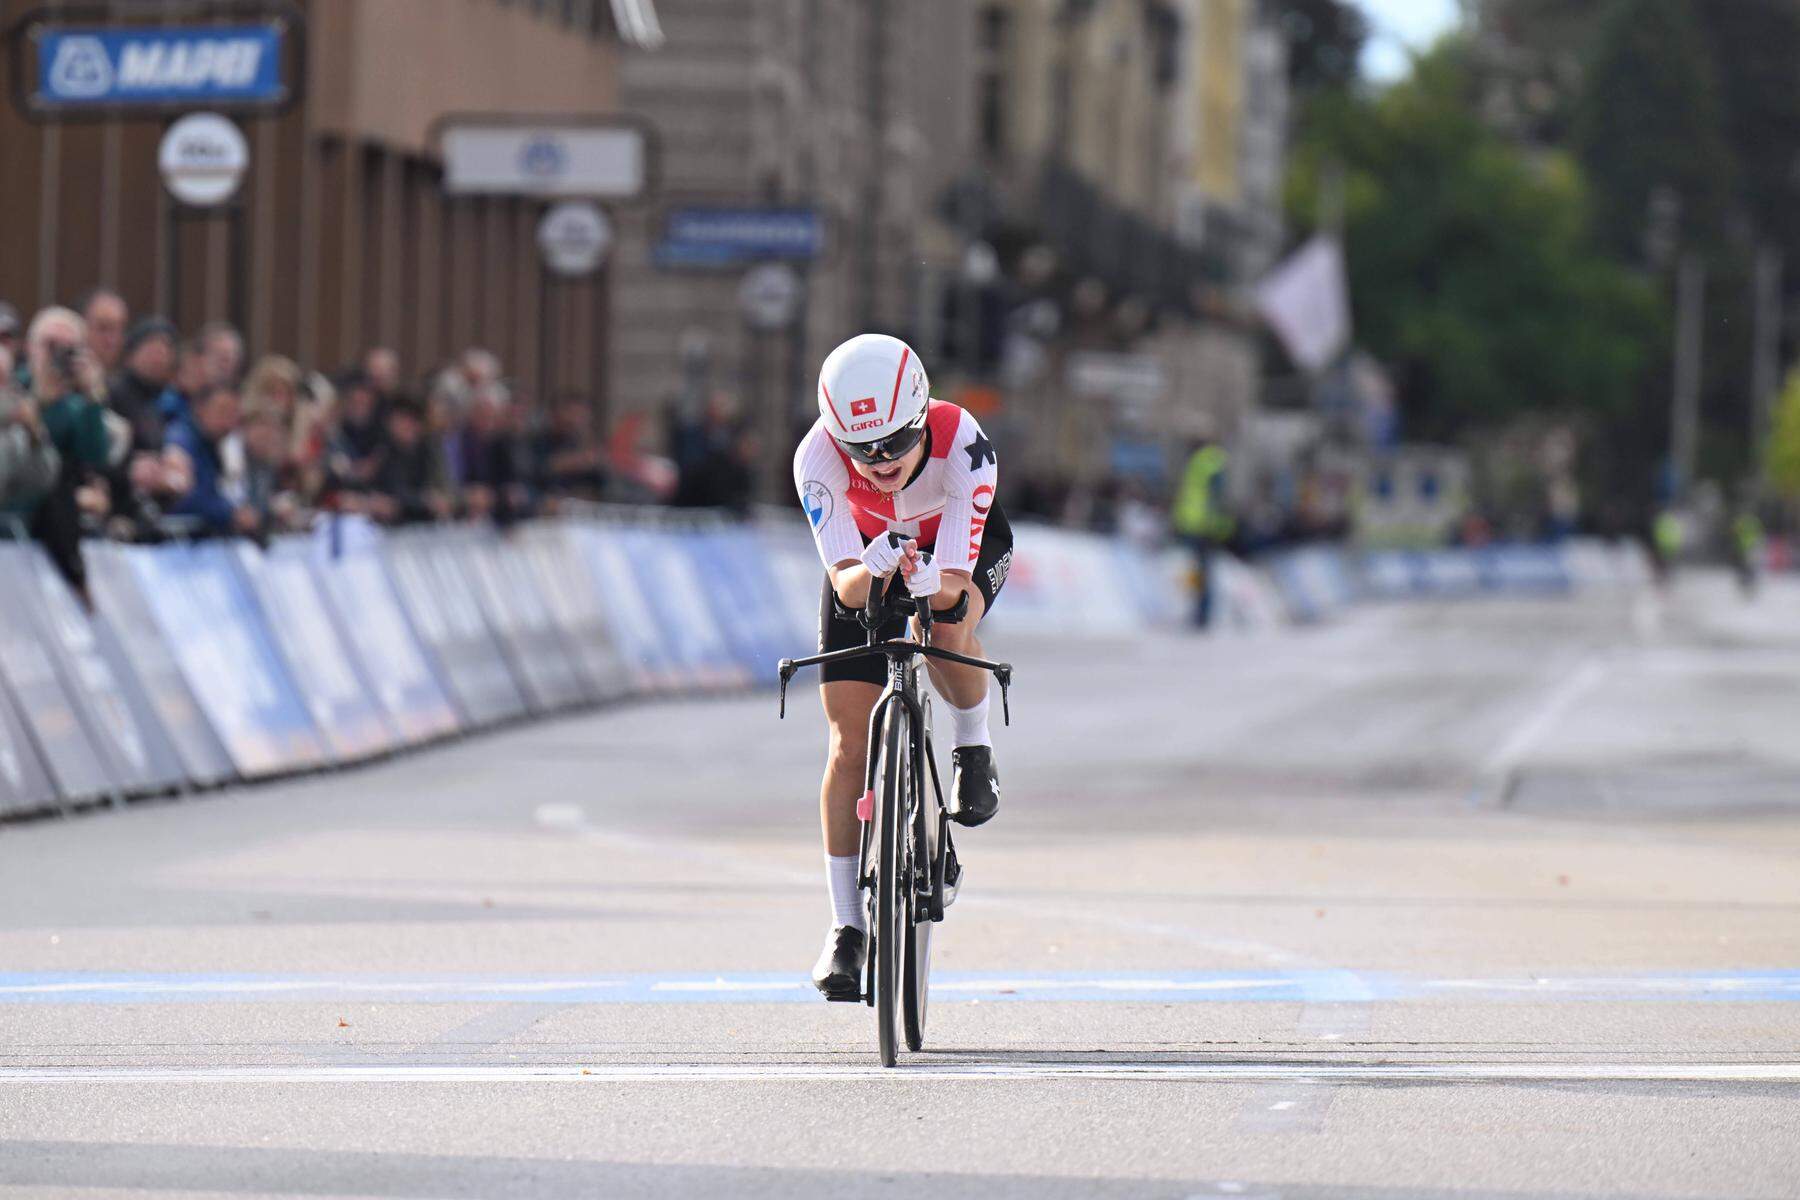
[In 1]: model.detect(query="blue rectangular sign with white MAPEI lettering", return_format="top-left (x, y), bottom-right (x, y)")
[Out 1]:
top-left (31, 22), bottom-right (288, 110)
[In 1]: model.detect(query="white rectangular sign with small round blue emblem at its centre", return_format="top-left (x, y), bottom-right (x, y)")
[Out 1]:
top-left (443, 119), bottom-right (648, 200)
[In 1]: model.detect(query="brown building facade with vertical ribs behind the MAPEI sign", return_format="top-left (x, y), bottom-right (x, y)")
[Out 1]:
top-left (0, 0), bottom-right (655, 394)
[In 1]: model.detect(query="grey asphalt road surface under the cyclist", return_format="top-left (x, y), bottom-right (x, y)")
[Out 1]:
top-left (0, 579), bottom-right (1800, 1200)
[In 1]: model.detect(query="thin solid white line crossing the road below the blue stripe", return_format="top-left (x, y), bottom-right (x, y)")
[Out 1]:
top-left (0, 1061), bottom-right (1800, 1085)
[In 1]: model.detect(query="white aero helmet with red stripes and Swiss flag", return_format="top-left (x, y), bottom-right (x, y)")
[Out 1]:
top-left (819, 333), bottom-right (931, 462)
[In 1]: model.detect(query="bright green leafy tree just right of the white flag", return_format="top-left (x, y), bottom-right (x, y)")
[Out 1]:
top-left (1289, 41), bottom-right (1660, 439)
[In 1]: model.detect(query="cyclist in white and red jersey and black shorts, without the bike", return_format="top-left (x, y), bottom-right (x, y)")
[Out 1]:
top-left (794, 333), bottom-right (1012, 1000)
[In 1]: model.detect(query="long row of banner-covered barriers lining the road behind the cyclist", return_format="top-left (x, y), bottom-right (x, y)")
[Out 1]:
top-left (0, 513), bottom-right (1642, 815)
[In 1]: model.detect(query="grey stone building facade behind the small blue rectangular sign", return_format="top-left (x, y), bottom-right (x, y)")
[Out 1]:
top-left (612, 0), bottom-right (974, 500)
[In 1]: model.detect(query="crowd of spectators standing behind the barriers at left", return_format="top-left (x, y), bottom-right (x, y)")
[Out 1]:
top-left (0, 288), bottom-right (754, 596)
